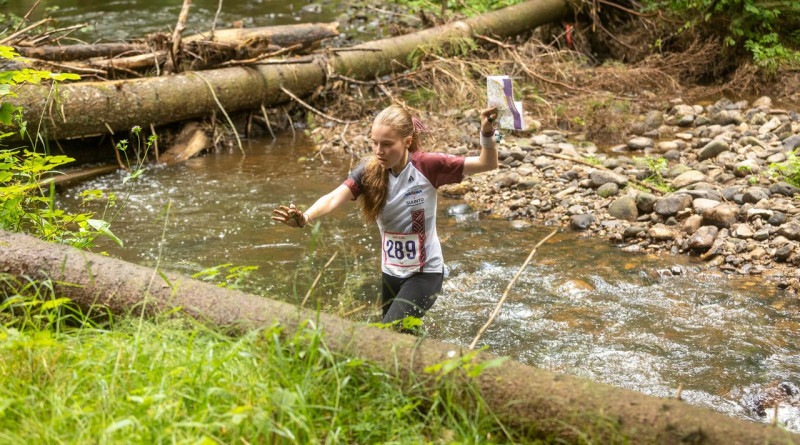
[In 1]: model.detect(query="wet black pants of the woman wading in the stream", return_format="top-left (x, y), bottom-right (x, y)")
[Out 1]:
top-left (381, 272), bottom-right (444, 323)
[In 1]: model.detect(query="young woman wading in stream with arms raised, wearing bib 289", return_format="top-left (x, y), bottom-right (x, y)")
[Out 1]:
top-left (272, 105), bottom-right (497, 330)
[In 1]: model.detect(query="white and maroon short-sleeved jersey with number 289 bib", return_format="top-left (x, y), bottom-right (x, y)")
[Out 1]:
top-left (344, 151), bottom-right (464, 278)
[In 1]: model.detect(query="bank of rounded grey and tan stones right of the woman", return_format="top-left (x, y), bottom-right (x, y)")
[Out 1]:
top-left (443, 97), bottom-right (800, 291)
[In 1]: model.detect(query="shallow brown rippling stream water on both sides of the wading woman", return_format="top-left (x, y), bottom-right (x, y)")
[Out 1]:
top-left (56, 134), bottom-right (800, 431)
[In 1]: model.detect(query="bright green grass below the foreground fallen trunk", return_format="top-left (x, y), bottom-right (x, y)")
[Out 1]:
top-left (0, 277), bottom-right (518, 444)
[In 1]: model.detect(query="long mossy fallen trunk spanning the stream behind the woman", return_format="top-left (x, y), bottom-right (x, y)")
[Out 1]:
top-left (6, 0), bottom-right (568, 139)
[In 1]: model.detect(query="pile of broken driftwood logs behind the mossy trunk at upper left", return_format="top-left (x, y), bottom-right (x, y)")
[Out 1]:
top-left (9, 20), bottom-right (339, 80)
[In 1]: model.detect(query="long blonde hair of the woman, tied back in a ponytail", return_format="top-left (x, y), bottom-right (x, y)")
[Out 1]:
top-left (361, 105), bottom-right (419, 223)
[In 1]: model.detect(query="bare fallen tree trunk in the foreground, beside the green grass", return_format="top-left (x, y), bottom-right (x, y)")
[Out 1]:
top-left (0, 227), bottom-right (800, 444)
